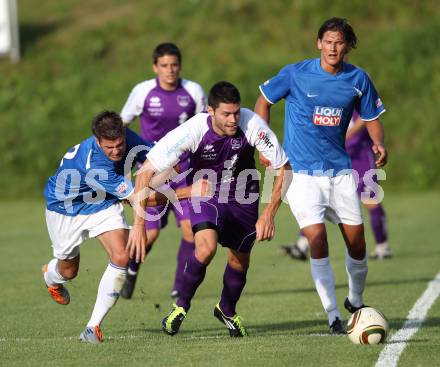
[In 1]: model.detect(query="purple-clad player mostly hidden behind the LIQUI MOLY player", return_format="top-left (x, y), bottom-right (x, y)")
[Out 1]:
top-left (281, 111), bottom-right (392, 260)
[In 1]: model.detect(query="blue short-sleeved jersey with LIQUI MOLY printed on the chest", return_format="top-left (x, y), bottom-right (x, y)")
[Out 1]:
top-left (260, 59), bottom-right (385, 176)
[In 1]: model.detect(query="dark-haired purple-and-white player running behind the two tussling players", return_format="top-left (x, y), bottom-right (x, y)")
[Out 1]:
top-left (121, 43), bottom-right (206, 298)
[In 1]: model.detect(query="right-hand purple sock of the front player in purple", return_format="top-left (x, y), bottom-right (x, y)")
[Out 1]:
top-left (220, 264), bottom-right (247, 317)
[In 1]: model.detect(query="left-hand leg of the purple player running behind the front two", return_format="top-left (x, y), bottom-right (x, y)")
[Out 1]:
top-left (121, 205), bottom-right (169, 299)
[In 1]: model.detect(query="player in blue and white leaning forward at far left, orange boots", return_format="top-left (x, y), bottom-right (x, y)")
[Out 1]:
top-left (43, 111), bottom-right (205, 344)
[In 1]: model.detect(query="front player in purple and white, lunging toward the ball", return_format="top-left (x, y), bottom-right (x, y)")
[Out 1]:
top-left (129, 82), bottom-right (289, 337)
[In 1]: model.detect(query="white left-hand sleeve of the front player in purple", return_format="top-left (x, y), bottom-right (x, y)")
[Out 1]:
top-left (147, 113), bottom-right (209, 172)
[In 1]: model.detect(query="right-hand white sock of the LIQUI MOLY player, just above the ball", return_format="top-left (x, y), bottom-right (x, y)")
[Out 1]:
top-left (345, 252), bottom-right (368, 307)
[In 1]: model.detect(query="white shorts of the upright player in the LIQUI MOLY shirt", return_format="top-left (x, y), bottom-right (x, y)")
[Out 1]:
top-left (286, 173), bottom-right (362, 229)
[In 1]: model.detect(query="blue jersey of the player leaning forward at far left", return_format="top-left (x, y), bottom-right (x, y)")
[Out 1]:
top-left (44, 129), bottom-right (153, 216)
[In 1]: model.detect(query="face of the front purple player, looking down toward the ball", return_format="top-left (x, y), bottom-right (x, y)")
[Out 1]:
top-left (208, 102), bottom-right (240, 136)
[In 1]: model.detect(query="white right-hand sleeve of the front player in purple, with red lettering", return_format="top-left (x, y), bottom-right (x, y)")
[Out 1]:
top-left (240, 108), bottom-right (288, 169)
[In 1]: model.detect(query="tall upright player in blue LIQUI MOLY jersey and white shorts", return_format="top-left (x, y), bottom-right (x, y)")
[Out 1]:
top-left (255, 18), bottom-right (387, 334)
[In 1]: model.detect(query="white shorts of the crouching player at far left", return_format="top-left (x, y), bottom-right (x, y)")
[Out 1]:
top-left (46, 203), bottom-right (129, 260)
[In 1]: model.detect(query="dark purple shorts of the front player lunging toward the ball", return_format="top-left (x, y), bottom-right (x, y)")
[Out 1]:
top-left (189, 197), bottom-right (258, 252)
